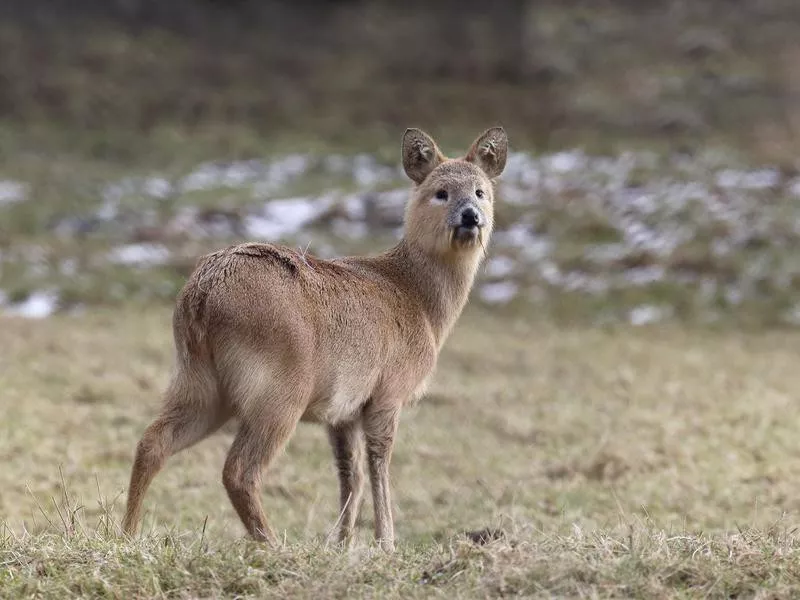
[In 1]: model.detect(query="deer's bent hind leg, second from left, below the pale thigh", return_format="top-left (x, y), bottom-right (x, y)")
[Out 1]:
top-left (222, 410), bottom-right (300, 545)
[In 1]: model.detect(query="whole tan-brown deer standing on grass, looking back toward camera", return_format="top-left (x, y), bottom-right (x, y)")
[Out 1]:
top-left (123, 127), bottom-right (508, 551)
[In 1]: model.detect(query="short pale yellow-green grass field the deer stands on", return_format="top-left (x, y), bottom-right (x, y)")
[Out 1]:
top-left (0, 308), bottom-right (800, 598)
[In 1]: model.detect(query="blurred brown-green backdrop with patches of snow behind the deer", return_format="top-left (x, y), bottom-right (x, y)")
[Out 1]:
top-left (0, 0), bottom-right (800, 326)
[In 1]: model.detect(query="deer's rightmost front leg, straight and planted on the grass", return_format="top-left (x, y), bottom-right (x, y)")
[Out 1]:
top-left (363, 399), bottom-right (400, 552)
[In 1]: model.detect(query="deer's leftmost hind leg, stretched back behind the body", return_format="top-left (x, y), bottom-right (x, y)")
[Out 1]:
top-left (122, 370), bottom-right (231, 535)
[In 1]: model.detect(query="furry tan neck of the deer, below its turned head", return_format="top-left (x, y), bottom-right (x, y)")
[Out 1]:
top-left (386, 238), bottom-right (483, 347)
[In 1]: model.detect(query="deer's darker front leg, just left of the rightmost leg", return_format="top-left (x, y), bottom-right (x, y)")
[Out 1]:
top-left (328, 419), bottom-right (364, 544)
